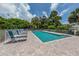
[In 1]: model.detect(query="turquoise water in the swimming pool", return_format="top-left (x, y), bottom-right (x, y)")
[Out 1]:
top-left (33, 31), bottom-right (65, 42)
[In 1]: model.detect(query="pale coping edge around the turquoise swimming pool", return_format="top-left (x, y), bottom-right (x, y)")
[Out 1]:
top-left (31, 30), bottom-right (76, 44)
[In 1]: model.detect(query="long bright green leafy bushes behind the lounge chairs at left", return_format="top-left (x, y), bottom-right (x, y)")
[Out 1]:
top-left (0, 17), bottom-right (30, 29)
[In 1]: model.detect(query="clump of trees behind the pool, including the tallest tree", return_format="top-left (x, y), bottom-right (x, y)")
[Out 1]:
top-left (31, 11), bottom-right (61, 29)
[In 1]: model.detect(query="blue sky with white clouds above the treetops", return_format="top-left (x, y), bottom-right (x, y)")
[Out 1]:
top-left (0, 3), bottom-right (79, 24)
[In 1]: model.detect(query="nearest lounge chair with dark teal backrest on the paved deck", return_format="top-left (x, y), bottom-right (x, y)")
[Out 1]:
top-left (4, 30), bottom-right (27, 43)
